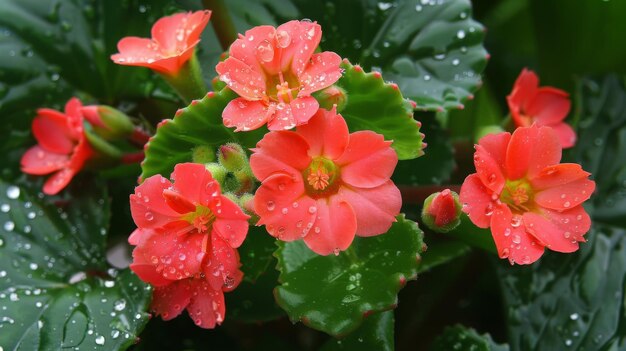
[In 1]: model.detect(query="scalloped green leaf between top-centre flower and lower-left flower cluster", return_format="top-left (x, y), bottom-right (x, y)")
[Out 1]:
top-left (141, 89), bottom-right (267, 179)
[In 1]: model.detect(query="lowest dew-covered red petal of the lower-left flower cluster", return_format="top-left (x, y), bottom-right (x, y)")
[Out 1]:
top-left (187, 279), bottom-right (226, 329)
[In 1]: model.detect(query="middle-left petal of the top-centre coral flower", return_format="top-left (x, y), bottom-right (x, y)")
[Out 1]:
top-left (215, 57), bottom-right (266, 100)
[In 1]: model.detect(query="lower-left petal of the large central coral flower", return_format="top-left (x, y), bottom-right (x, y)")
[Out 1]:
top-left (254, 173), bottom-right (317, 241)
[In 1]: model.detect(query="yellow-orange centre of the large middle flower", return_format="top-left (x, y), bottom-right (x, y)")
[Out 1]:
top-left (302, 157), bottom-right (341, 198)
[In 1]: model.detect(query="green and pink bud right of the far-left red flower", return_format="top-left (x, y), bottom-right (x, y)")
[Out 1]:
top-left (81, 105), bottom-right (135, 140)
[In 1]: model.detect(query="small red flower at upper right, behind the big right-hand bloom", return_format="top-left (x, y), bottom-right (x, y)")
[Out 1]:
top-left (507, 69), bottom-right (576, 148)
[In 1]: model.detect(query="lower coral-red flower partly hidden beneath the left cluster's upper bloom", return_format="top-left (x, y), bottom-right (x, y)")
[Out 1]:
top-left (128, 229), bottom-right (243, 328)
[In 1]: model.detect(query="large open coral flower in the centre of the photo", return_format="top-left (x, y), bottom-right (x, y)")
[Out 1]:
top-left (250, 109), bottom-right (402, 255)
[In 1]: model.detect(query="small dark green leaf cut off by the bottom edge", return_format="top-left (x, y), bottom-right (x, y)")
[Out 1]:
top-left (430, 325), bottom-right (509, 351)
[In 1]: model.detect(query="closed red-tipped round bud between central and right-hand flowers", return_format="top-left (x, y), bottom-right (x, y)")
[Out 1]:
top-left (422, 189), bottom-right (462, 233)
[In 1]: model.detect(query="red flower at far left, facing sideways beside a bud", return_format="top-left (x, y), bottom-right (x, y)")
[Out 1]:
top-left (21, 98), bottom-right (94, 195)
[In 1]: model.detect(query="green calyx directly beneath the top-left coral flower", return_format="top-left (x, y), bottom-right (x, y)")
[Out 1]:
top-left (161, 52), bottom-right (207, 103)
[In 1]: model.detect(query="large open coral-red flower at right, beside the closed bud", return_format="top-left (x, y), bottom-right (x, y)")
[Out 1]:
top-left (460, 125), bottom-right (595, 264)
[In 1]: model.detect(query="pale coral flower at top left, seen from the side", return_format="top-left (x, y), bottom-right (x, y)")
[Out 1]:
top-left (111, 10), bottom-right (211, 75)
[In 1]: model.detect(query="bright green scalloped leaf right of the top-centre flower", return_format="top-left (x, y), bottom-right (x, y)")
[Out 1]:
top-left (337, 61), bottom-right (423, 160)
